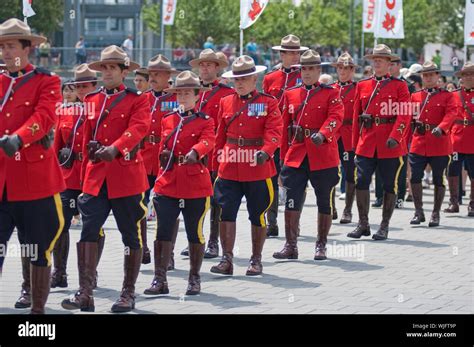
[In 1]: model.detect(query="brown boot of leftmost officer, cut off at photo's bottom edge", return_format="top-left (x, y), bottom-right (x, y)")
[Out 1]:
top-left (30, 264), bottom-right (51, 314)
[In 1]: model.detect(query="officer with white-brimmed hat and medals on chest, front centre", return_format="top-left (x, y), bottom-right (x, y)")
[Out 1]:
top-left (211, 55), bottom-right (282, 276)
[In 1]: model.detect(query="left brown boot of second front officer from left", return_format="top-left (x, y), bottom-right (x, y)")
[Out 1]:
top-left (61, 242), bottom-right (99, 312)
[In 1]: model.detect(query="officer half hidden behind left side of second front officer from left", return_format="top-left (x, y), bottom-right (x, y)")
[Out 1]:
top-left (51, 64), bottom-right (105, 288)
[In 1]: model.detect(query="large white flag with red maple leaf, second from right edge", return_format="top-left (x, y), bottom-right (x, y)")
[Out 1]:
top-left (374, 0), bottom-right (405, 39)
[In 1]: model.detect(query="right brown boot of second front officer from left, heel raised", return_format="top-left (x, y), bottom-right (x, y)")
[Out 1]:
top-left (111, 248), bottom-right (143, 313)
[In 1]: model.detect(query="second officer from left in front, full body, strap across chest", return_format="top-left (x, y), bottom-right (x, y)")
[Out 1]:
top-left (62, 45), bottom-right (151, 312)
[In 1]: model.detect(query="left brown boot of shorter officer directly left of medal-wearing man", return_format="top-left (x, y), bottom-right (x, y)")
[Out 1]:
top-left (144, 240), bottom-right (173, 296)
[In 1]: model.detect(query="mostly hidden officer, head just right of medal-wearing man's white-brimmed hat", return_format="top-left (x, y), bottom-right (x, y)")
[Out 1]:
top-left (263, 34), bottom-right (308, 236)
